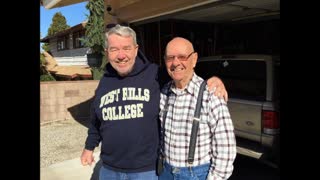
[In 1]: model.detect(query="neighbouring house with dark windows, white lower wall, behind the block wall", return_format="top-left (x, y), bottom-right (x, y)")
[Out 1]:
top-left (40, 22), bottom-right (101, 80)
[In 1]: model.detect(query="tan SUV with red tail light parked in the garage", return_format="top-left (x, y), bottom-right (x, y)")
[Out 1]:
top-left (195, 54), bottom-right (280, 167)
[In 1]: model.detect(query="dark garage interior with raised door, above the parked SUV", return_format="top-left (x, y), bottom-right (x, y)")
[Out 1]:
top-left (129, 0), bottom-right (280, 65)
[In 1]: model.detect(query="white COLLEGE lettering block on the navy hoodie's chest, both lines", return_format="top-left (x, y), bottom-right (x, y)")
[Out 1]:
top-left (99, 87), bottom-right (150, 121)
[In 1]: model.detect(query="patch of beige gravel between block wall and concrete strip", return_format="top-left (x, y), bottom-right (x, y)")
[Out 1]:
top-left (40, 120), bottom-right (88, 168)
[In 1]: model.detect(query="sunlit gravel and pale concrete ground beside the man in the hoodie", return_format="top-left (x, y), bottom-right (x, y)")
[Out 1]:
top-left (40, 120), bottom-right (101, 180)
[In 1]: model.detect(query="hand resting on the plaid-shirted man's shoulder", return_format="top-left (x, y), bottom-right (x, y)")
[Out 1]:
top-left (207, 76), bottom-right (228, 102)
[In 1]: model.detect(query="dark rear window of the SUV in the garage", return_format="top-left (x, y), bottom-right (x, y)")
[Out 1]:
top-left (195, 60), bottom-right (266, 101)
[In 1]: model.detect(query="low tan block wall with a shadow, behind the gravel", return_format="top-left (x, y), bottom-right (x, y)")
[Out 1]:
top-left (40, 80), bottom-right (99, 124)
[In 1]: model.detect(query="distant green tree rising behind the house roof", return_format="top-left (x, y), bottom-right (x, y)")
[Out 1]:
top-left (48, 12), bottom-right (70, 36)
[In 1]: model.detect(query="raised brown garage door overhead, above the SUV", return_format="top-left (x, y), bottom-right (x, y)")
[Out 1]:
top-left (129, 0), bottom-right (280, 24)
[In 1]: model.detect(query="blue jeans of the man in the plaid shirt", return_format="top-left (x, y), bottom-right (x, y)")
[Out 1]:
top-left (159, 162), bottom-right (210, 180)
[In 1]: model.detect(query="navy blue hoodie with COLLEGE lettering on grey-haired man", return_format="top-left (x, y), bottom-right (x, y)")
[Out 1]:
top-left (85, 52), bottom-right (160, 172)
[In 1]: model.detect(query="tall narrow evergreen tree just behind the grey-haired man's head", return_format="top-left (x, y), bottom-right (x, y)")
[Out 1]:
top-left (81, 0), bottom-right (107, 79)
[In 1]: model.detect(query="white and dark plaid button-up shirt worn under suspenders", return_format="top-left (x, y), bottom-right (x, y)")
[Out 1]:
top-left (160, 73), bottom-right (236, 180)
